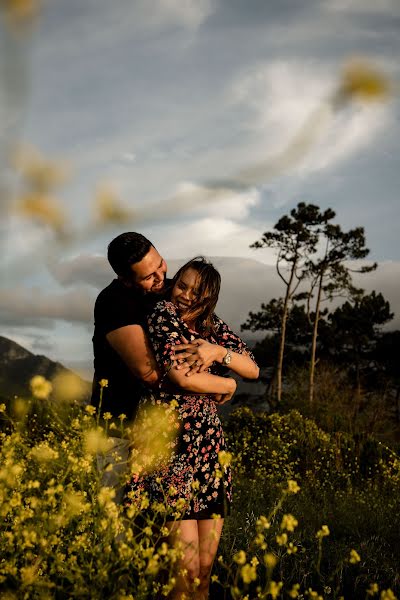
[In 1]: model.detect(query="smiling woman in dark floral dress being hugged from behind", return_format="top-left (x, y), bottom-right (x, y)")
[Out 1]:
top-left (129, 258), bottom-right (259, 600)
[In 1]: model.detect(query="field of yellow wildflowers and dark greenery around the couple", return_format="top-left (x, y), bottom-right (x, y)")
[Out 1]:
top-left (0, 378), bottom-right (400, 600)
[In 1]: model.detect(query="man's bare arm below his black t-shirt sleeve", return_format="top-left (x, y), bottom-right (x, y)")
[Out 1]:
top-left (106, 325), bottom-right (160, 385)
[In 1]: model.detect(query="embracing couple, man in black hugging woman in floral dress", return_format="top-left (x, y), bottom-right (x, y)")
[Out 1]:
top-left (93, 232), bottom-right (259, 600)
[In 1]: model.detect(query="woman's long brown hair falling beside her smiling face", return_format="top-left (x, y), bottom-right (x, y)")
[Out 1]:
top-left (172, 256), bottom-right (221, 334)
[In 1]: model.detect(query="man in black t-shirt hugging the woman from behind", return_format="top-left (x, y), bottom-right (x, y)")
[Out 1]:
top-left (92, 232), bottom-right (167, 419)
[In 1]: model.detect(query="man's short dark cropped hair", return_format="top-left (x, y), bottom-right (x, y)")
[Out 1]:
top-left (107, 231), bottom-right (153, 277)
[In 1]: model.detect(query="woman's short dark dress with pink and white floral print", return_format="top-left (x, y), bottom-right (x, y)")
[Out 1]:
top-left (127, 301), bottom-right (253, 519)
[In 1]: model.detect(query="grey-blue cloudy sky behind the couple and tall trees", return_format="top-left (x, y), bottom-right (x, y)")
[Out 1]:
top-left (0, 0), bottom-right (400, 376)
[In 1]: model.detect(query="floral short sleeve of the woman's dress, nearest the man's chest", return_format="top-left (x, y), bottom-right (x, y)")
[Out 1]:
top-left (147, 300), bottom-right (195, 373)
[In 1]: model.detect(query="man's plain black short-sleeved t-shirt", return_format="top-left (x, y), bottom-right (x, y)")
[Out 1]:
top-left (92, 279), bottom-right (148, 419)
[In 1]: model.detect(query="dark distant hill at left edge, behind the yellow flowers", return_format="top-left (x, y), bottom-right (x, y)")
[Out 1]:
top-left (0, 336), bottom-right (91, 400)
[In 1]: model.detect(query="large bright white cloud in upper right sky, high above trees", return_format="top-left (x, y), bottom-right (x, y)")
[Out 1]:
top-left (232, 59), bottom-right (389, 175)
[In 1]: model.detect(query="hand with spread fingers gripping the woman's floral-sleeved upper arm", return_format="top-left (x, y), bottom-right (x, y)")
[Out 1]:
top-left (171, 338), bottom-right (226, 377)
